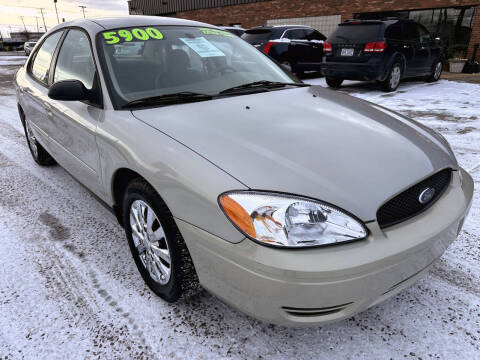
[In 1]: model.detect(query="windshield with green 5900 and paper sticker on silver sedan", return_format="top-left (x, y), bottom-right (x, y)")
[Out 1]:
top-left (97, 26), bottom-right (301, 108)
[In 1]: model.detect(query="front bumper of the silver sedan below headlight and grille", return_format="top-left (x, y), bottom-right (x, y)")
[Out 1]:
top-left (177, 169), bottom-right (473, 326)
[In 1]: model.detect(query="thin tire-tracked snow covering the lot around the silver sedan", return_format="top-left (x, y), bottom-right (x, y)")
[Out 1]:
top-left (0, 57), bottom-right (480, 359)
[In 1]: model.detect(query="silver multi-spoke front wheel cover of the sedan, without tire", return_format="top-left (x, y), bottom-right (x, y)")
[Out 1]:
top-left (130, 200), bottom-right (172, 285)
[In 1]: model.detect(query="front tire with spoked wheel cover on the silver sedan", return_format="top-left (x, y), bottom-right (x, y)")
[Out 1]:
top-left (122, 179), bottom-right (201, 302)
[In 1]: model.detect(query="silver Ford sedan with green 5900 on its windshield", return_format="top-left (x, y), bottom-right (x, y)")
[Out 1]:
top-left (15, 16), bottom-right (473, 326)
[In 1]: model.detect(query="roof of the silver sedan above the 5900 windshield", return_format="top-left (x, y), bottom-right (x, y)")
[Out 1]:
top-left (48, 15), bottom-right (215, 31)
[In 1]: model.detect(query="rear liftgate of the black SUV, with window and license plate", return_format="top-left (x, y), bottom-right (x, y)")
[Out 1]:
top-left (327, 21), bottom-right (384, 63)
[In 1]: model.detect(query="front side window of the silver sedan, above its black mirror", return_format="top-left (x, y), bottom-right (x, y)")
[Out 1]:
top-left (53, 30), bottom-right (95, 89)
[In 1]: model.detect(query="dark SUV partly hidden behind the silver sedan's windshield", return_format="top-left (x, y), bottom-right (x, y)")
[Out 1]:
top-left (242, 25), bottom-right (326, 74)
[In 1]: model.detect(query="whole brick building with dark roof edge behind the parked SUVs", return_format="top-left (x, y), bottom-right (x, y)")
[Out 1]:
top-left (128, 0), bottom-right (480, 60)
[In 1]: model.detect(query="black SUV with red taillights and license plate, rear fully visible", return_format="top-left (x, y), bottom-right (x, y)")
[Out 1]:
top-left (322, 19), bottom-right (444, 91)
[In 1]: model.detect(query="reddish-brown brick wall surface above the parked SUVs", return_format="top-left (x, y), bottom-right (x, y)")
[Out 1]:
top-left (175, 0), bottom-right (480, 59)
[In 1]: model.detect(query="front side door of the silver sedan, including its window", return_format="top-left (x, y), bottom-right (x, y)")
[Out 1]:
top-left (49, 28), bottom-right (103, 193)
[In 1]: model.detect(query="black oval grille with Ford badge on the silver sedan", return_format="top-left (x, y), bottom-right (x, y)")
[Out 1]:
top-left (377, 169), bottom-right (452, 229)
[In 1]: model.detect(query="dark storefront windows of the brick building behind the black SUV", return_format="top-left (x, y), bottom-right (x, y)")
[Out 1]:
top-left (355, 6), bottom-right (475, 57)
